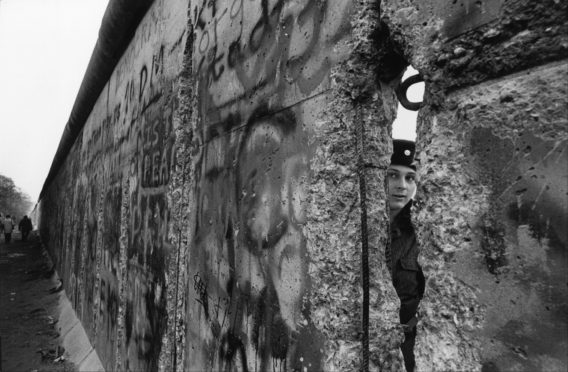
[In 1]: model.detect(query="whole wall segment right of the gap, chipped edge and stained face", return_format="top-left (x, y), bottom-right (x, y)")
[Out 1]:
top-left (382, 0), bottom-right (568, 371)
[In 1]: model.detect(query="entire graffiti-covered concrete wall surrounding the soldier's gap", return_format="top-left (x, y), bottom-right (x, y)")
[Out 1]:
top-left (38, 0), bottom-right (568, 371)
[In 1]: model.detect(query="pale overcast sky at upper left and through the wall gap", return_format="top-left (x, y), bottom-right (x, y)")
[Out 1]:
top-left (0, 0), bottom-right (423, 201)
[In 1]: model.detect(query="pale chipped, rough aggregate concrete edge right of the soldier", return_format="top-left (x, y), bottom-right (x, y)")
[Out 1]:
top-left (408, 109), bottom-right (489, 371)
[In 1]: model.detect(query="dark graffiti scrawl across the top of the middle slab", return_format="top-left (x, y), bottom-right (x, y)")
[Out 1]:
top-left (193, 0), bottom-right (349, 115)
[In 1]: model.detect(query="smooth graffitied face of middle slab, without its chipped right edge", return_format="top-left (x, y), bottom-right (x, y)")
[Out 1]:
top-left (187, 0), bottom-right (350, 371)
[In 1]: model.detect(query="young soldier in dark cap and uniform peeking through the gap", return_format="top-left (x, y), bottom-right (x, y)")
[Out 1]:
top-left (386, 139), bottom-right (425, 371)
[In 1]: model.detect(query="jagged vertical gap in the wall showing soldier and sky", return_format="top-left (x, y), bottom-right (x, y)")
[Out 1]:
top-left (386, 66), bottom-right (426, 370)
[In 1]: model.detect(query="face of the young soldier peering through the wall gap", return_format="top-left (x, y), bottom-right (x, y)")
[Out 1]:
top-left (387, 165), bottom-right (416, 214)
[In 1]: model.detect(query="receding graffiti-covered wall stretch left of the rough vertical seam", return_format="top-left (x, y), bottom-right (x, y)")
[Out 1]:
top-left (40, 0), bottom-right (188, 370)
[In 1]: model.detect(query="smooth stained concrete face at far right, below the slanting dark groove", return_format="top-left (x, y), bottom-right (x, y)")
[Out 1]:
top-left (451, 63), bottom-right (568, 371)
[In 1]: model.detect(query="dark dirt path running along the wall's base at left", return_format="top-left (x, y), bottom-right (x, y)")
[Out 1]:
top-left (0, 232), bottom-right (76, 372)
